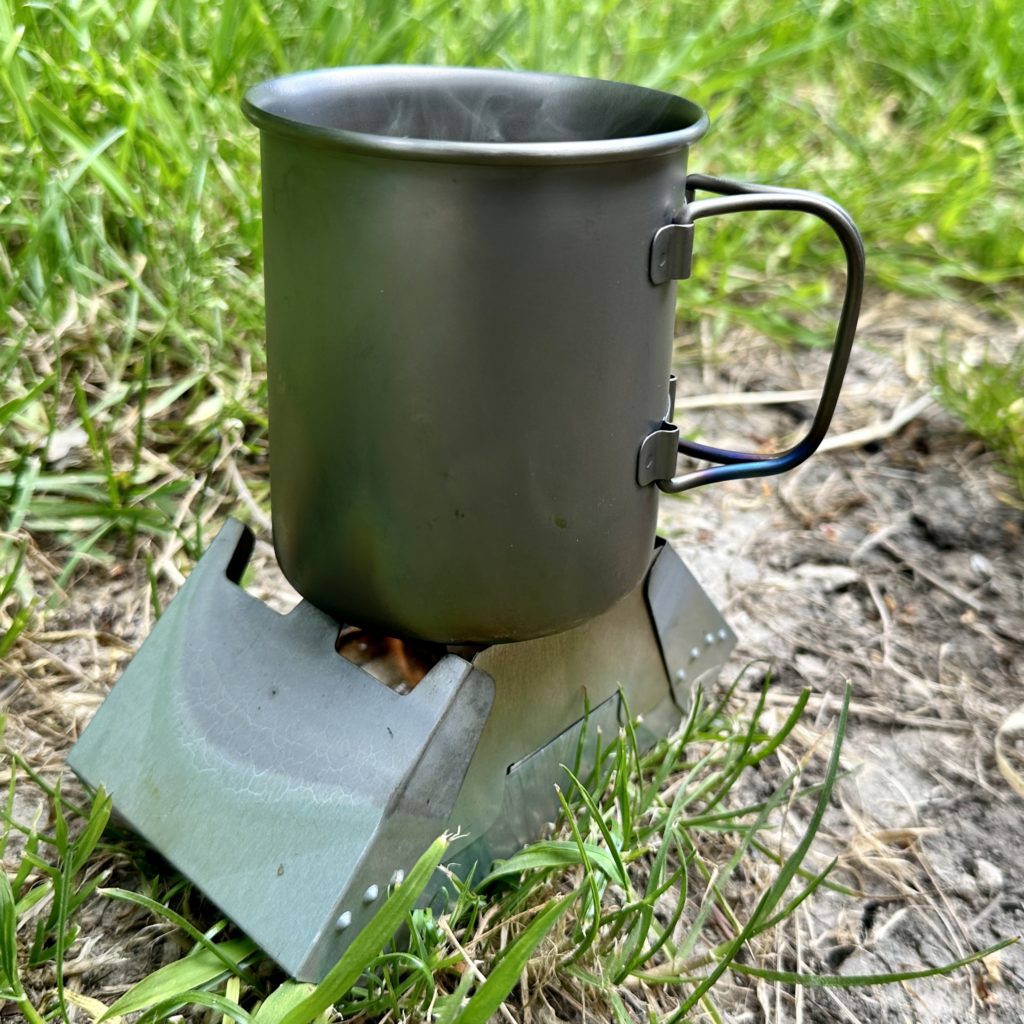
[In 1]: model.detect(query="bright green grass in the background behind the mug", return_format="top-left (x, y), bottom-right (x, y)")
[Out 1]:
top-left (0, 0), bottom-right (1024, 589)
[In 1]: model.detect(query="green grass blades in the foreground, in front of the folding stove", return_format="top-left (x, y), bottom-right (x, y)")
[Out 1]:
top-left (0, 682), bottom-right (1007, 1024)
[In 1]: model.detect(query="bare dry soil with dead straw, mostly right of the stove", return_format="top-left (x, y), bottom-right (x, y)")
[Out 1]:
top-left (0, 297), bottom-right (1024, 1024)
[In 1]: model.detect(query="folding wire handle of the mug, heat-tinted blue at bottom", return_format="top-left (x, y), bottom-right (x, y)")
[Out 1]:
top-left (638, 174), bottom-right (864, 494)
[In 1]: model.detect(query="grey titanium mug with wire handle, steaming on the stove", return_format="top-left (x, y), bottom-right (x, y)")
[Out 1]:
top-left (243, 67), bottom-right (864, 644)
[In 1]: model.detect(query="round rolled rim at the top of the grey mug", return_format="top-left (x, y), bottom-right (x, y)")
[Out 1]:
top-left (242, 65), bottom-right (710, 164)
